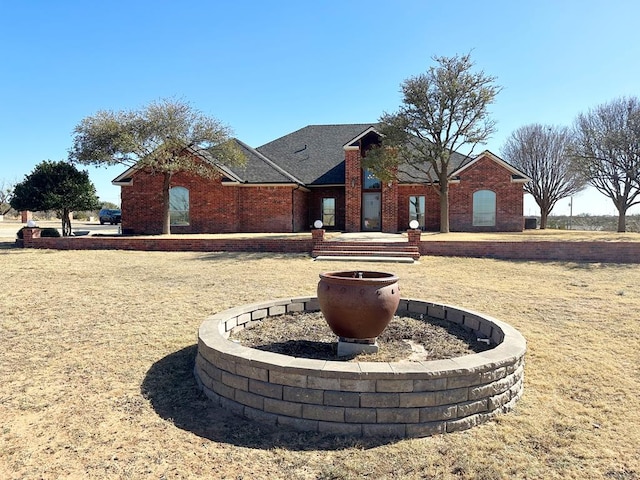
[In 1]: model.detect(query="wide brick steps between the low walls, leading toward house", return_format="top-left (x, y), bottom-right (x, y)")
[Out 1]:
top-left (311, 241), bottom-right (420, 262)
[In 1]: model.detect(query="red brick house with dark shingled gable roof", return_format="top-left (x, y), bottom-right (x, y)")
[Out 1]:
top-left (112, 124), bottom-right (530, 234)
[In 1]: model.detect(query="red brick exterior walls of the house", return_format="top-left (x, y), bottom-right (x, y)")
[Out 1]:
top-left (121, 150), bottom-right (524, 235)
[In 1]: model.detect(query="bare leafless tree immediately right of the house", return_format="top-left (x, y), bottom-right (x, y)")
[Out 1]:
top-left (502, 123), bottom-right (586, 229)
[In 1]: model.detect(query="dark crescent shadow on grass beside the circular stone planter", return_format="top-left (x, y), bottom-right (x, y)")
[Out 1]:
top-left (140, 345), bottom-right (396, 451)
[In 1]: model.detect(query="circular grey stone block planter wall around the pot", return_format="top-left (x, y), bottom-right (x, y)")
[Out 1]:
top-left (195, 297), bottom-right (526, 437)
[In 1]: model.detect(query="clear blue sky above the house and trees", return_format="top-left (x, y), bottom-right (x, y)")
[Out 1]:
top-left (0, 0), bottom-right (640, 215)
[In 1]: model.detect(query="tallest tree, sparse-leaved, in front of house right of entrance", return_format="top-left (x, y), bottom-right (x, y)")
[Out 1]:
top-left (365, 54), bottom-right (501, 233)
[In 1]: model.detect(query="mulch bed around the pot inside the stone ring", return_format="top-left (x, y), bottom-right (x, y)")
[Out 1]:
top-left (231, 312), bottom-right (491, 362)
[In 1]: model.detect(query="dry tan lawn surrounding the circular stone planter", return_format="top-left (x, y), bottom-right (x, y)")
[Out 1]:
top-left (0, 249), bottom-right (640, 480)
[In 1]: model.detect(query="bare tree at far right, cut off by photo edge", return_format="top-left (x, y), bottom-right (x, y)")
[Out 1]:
top-left (573, 97), bottom-right (640, 232)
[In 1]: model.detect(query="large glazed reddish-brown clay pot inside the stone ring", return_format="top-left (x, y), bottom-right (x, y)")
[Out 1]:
top-left (318, 271), bottom-right (400, 339)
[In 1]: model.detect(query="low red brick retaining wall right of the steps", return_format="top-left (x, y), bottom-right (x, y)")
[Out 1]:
top-left (420, 241), bottom-right (640, 263)
